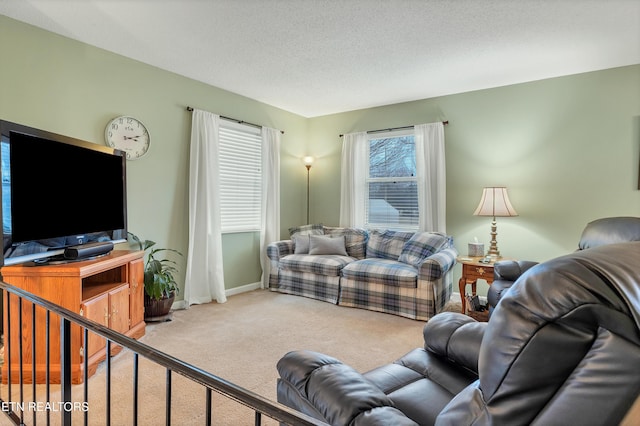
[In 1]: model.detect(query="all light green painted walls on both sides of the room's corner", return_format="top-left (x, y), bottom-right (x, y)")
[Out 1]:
top-left (0, 16), bottom-right (640, 298)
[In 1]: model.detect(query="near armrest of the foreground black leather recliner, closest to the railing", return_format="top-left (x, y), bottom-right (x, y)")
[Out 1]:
top-left (277, 351), bottom-right (416, 425)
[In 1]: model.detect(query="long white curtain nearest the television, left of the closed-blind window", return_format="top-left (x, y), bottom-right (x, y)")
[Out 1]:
top-left (184, 110), bottom-right (227, 307)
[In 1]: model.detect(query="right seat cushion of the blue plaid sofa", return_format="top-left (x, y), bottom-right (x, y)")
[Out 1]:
top-left (342, 259), bottom-right (418, 288)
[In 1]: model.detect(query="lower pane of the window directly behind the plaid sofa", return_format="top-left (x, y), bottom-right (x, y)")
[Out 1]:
top-left (367, 181), bottom-right (418, 227)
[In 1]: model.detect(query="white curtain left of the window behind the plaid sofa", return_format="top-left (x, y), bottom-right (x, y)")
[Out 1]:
top-left (340, 132), bottom-right (369, 228)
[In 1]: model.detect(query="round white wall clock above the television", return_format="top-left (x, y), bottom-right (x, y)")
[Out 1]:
top-left (104, 116), bottom-right (150, 160)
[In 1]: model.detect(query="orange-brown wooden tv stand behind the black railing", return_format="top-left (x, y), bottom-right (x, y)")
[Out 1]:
top-left (1, 250), bottom-right (146, 383)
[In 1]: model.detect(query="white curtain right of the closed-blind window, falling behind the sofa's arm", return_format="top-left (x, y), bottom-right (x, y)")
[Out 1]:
top-left (260, 127), bottom-right (281, 288)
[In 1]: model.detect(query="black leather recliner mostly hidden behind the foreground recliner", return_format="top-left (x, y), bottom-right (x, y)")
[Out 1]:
top-left (487, 216), bottom-right (640, 315)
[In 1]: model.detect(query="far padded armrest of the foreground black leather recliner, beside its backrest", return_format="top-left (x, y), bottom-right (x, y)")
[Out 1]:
top-left (423, 312), bottom-right (487, 375)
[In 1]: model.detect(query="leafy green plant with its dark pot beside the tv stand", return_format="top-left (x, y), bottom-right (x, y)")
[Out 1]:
top-left (129, 232), bottom-right (182, 321)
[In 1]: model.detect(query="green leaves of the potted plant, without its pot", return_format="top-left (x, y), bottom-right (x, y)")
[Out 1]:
top-left (129, 232), bottom-right (182, 300)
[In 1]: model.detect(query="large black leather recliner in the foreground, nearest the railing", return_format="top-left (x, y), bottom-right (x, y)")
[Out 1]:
top-left (277, 242), bottom-right (640, 426)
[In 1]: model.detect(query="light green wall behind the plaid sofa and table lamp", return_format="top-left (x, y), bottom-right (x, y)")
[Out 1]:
top-left (309, 65), bottom-right (640, 292)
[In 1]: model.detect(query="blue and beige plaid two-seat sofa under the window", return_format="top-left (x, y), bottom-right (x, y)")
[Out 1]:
top-left (267, 225), bottom-right (457, 321)
